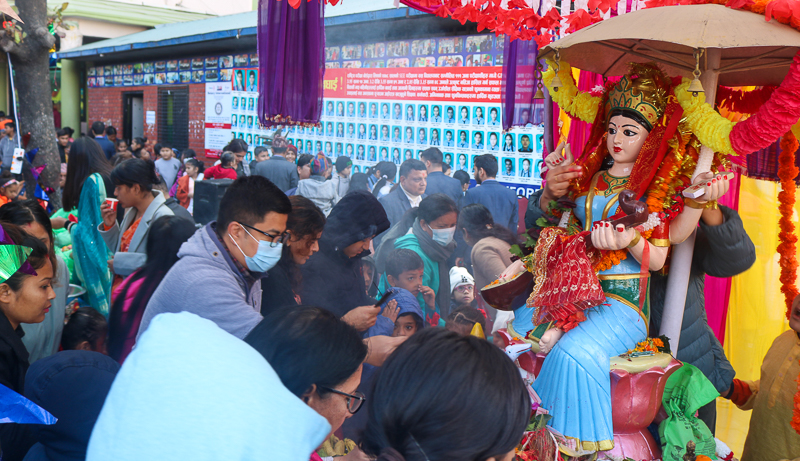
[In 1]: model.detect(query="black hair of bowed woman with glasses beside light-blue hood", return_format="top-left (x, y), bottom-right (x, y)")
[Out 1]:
top-left (244, 306), bottom-right (367, 397)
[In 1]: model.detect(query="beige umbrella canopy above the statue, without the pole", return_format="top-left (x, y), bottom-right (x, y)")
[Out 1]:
top-left (539, 4), bottom-right (800, 86)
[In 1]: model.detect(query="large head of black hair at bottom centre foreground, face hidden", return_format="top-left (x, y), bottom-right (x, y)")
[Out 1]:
top-left (362, 328), bottom-right (531, 461)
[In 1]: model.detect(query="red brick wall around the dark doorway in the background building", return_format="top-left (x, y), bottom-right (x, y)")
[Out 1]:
top-left (87, 83), bottom-right (206, 163)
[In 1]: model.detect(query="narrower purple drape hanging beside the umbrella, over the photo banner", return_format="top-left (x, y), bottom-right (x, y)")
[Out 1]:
top-left (500, 36), bottom-right (547, 130)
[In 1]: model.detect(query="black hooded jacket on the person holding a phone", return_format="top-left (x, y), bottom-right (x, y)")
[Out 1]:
top-left (300, 191), bottom-right (389, 317)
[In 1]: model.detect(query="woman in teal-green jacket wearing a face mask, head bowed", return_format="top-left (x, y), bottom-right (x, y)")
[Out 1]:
top-left (376, 194), bottom-right (458, 326)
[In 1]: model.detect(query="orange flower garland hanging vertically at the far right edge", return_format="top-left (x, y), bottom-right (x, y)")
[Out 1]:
top-left (778, 131), bottom-right (800, 319)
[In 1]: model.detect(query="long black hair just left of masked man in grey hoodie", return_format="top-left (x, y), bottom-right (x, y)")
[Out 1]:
top-left (108, 216), bottom-right (197, 361)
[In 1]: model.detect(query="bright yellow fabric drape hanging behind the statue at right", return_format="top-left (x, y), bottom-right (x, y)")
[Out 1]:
top-left (716, 177), bottom-right (800, 457)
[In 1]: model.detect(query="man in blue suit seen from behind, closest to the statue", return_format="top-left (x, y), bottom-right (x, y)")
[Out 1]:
top-left (461, 154), bottom-right (519, 233)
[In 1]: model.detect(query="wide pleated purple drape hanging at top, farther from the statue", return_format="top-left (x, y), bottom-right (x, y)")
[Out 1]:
top-left (258, 0), bottom-right (325, 127)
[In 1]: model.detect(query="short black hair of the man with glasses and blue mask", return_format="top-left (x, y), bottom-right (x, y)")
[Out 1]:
top-left (217, 175), bottom-right (292, 235)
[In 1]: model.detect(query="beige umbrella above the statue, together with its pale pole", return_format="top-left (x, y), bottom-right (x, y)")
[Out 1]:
top-left (540, 4), bottom-right (800, 350)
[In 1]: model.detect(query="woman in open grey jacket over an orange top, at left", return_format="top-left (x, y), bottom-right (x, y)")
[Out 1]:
top-left (98, 158), bottom-right (174, 282)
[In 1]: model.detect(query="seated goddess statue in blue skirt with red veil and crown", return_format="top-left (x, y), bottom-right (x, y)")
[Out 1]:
top-left (506, 63), bottom-right (729, 455)
